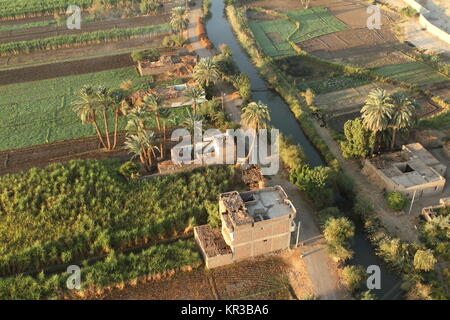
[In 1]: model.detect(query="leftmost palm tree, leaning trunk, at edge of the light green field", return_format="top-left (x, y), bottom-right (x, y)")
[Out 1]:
top-left (73, 86), bottom-right (106, 148)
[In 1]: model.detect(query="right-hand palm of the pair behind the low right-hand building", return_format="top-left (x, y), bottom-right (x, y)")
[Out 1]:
top-left (390, 92), bottom-right (416, 150)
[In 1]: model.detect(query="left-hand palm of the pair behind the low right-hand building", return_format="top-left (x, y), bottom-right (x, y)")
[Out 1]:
top-left (361, 88), bottom-right (393, 153)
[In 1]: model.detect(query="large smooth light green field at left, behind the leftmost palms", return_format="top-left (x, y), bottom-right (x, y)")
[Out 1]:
top-left (0, 67), bottom-right (184, 150)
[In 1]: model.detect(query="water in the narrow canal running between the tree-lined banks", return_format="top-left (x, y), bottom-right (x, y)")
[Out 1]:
top-left (206, 0), bottom-right (402, 299)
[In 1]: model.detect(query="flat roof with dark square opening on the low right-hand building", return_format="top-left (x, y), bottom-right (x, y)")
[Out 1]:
top-left (369, 143), bottom-right (447, 188)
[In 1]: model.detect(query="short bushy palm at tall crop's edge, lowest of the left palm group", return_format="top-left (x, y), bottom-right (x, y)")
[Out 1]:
top-left (125, 130), bottom-right (158, 169)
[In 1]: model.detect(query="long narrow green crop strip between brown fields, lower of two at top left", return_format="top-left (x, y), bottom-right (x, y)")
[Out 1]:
top-left (0, 23), bottom-right (170, 56)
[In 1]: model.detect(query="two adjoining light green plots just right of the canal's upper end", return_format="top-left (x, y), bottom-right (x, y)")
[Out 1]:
top-left (249, 7), bottom-right (347, 57)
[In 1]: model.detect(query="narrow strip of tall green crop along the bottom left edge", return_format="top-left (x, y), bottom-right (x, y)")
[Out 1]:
top-left (0, 240), bottom-right (201, 300)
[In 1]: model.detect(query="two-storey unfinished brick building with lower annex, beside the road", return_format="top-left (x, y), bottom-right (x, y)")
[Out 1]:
top-left (194, 186), bottom-right (296, 268)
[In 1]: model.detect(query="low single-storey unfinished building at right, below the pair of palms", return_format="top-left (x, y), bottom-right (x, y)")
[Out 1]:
top-left (363, 143), bottom-right (447, 198)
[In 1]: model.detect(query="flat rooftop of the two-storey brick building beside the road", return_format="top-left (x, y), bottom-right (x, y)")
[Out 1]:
top-left (220, 186), bottom-right (296, 226)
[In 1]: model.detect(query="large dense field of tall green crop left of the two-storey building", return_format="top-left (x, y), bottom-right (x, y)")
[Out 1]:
top-left (0, 159), bottom-right (239, 275)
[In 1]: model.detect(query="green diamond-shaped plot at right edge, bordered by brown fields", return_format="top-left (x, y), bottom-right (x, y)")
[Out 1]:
top-left (373, 62), bottom-right (450, 86)
